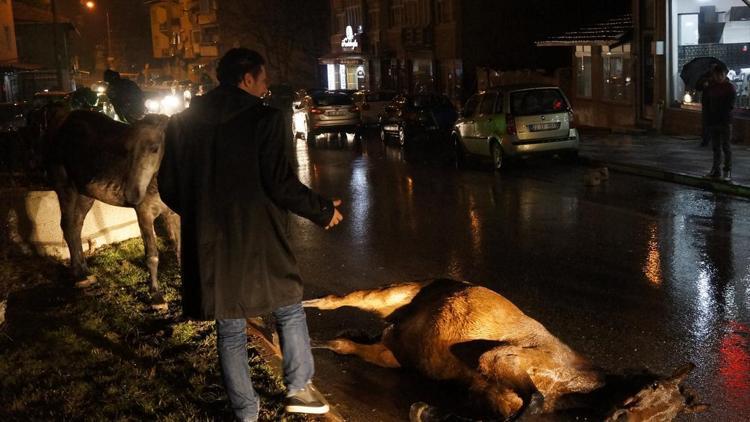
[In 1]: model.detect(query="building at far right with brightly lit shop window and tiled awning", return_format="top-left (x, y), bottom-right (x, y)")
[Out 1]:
top-left (538, 0), bottom-right (750, 143)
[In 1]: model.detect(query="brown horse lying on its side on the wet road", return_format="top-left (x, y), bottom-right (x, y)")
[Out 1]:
top-left (304, 279), bottom-right (704, 421)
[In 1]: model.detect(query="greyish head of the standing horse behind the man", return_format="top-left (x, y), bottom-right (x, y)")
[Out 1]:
top-left (125, 114), bottom-right (169, 205)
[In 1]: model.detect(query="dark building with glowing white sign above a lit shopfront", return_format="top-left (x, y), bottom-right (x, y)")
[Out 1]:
top-left (319, 0), bottom-right (463, 98)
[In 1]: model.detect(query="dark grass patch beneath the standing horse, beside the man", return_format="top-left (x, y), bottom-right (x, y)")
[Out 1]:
top-left (0, 239), bottom-right (307, 421)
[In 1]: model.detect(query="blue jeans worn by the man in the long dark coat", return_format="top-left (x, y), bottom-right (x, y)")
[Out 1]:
top-left (216, 303), bottom-right (315, 421)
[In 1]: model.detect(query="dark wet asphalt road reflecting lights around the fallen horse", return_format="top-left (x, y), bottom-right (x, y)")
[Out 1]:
top-left (284, 135), bottom-right (750, 421)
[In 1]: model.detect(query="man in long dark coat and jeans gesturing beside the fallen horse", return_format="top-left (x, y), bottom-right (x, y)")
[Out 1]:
top-left (158, 48), bottom-right (342, 421)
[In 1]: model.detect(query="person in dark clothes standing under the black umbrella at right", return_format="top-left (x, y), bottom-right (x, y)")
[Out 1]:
top-left (702, 65), bottom-right (736, 181)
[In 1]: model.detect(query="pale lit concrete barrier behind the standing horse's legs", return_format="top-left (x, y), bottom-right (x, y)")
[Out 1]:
top-left (0, 189), bottom-right (141, 259)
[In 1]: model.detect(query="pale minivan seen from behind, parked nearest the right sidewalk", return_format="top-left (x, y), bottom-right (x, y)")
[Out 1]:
top-left (452, 85), bottom-right (580, 170)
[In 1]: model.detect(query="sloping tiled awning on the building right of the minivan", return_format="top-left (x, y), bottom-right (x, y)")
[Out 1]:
top-left (535, 14), bottom-right (633, 47)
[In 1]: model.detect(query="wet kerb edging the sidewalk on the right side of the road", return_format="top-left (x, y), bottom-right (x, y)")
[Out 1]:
top-left (579, 156), bottom-right (750, 198)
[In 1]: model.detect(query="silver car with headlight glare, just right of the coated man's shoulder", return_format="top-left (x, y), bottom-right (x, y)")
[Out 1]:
top-left (293, 91), bottom-right (361, 141)
